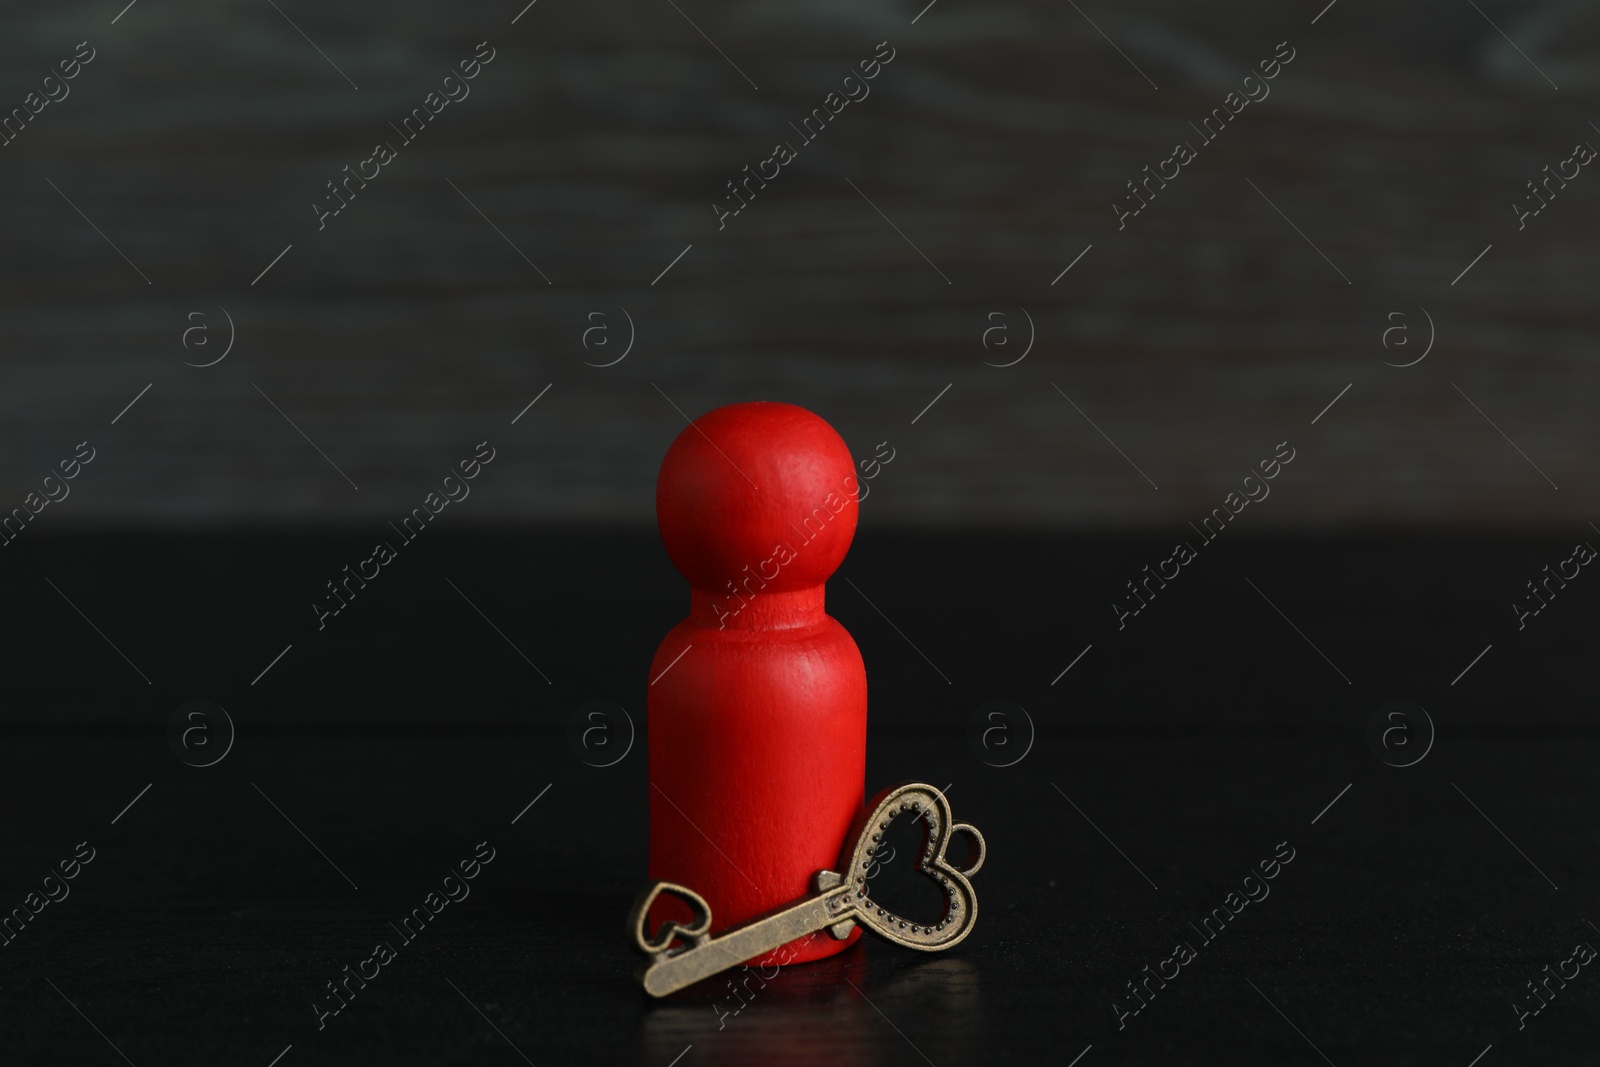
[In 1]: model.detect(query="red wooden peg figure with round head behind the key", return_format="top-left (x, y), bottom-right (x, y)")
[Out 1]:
top-left (648, 402), bottom-right (867, 965)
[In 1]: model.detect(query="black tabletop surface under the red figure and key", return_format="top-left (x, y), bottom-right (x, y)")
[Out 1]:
top-left (0, 531), bottom-right (1600, 1067)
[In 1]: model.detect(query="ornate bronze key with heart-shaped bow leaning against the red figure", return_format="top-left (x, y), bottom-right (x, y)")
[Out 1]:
top-left (627, 782), bottom-right (984, 997)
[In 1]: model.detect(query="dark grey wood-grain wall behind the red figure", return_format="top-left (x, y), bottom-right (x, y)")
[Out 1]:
top-left (0, 0), bottom-right (1600, 530)
